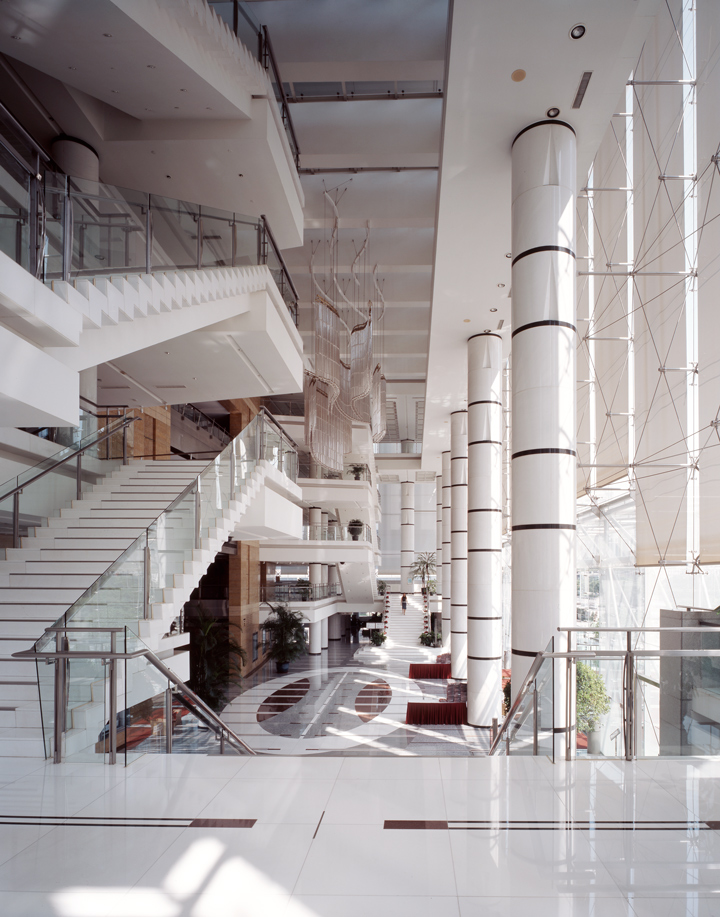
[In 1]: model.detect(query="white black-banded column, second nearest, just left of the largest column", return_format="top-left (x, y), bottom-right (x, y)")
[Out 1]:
top-left (467, 332), bottom-right (503, 728)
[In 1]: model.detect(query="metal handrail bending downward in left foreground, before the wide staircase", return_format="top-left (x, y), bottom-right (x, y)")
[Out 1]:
top-left (12, 626), bottom-right (257, 764)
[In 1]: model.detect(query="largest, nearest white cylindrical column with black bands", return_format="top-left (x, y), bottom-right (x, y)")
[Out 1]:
top-left (511, 121), bottom-right (576, 748)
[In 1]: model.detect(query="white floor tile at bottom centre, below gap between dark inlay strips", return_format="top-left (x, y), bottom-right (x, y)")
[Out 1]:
top-left (295, 825), bottom-right (456, 896)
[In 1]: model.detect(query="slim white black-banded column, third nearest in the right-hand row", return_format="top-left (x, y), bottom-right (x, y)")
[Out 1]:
top-left (450, 411), bottom-right (467, 678)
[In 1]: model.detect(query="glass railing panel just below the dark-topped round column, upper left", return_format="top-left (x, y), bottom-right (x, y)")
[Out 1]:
top-left (70, 178), bottom-right (148, 276)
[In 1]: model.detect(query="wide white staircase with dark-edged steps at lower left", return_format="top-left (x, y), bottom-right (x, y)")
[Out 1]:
top-left (0, 452), bottom-right (268, 757)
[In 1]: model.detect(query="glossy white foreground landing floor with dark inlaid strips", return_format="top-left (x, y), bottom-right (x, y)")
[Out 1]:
top-left (0, 755), bottom-right (720, 917)
